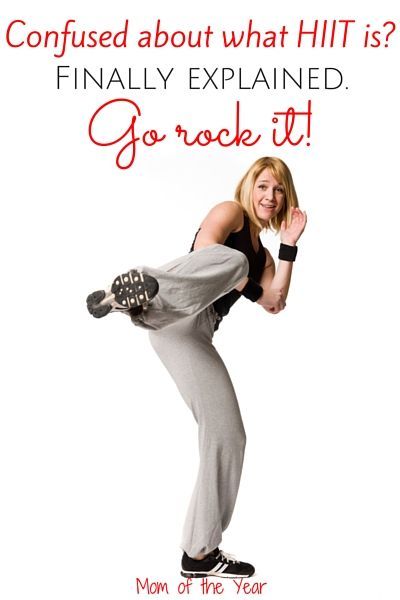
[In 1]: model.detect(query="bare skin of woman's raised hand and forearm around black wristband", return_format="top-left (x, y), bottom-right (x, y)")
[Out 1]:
top-left (260, 208), bottom-right (307, 310)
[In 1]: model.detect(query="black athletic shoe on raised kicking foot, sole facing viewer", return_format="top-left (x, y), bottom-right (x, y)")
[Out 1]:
top-left (86, 269), bottom-right (158, 319)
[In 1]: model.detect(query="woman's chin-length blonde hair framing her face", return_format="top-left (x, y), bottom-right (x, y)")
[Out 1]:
top-left (234, 156), bottom-right (299, 232)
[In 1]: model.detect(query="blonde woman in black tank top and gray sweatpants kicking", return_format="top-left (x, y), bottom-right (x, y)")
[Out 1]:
top-left (87, 157), bottom-right (307, 577)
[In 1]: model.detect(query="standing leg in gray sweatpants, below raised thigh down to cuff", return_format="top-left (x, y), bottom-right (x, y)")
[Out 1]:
top-left (150, 307), bottom-right (246, 557)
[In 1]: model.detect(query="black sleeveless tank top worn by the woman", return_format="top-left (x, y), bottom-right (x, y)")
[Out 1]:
top-left (190, 214), bottom-right (266, 330)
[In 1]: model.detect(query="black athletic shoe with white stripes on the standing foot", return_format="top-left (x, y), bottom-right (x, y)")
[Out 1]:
top-left (181, 548), bottom-right (255, 579)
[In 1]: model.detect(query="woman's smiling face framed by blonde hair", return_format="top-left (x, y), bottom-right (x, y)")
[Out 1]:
top-left (253, 168), bottom-right (285, 224)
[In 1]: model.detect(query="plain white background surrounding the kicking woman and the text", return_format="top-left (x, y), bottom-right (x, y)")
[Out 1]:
top-left (0, 2), bottom-right (400, 600)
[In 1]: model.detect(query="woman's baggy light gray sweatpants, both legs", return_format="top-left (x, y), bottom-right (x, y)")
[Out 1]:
top-left (132, 244), bottom-right (249, 557)
